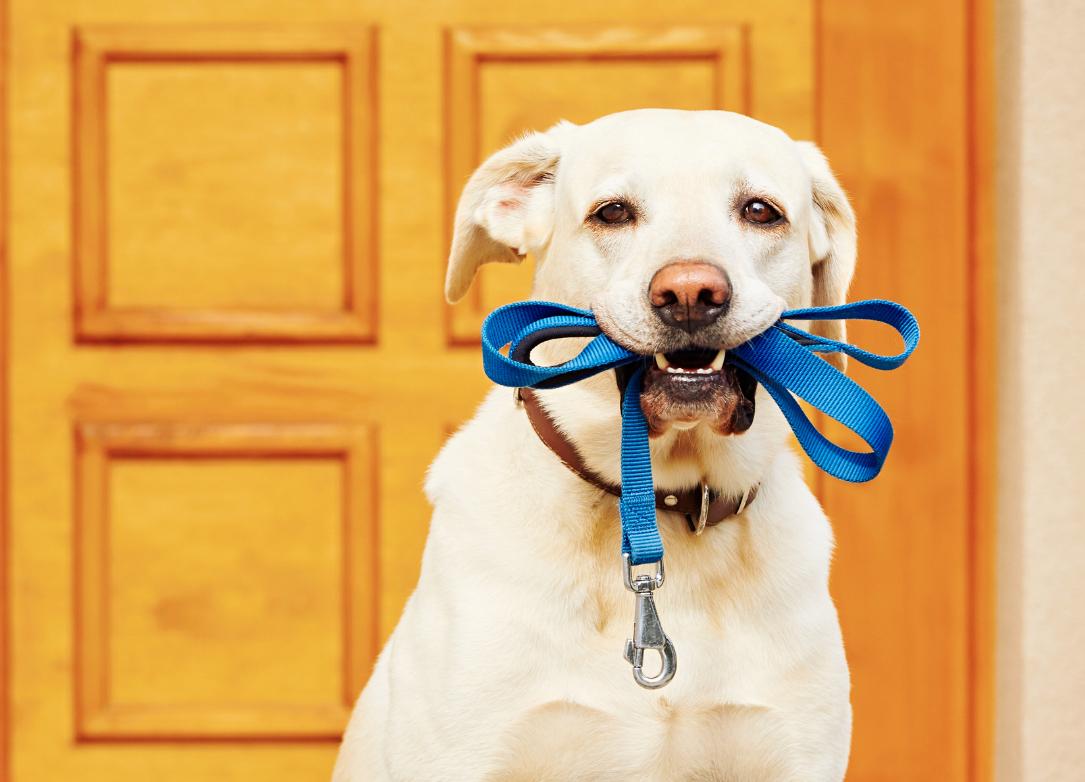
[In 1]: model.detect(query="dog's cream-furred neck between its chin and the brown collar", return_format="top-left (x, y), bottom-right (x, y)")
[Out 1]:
top-left (538, 372), bottom-right (788, 496)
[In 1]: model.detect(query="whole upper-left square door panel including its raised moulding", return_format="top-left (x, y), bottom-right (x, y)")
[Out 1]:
top-left (73, 24), bottom-right (378, 342)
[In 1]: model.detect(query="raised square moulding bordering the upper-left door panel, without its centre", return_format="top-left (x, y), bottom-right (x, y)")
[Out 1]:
top-left (73, 25), bottom-right (378, 343)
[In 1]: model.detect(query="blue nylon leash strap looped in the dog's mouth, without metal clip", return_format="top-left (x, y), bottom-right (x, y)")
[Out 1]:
top-left (482, 299), bottom-right (919, 565)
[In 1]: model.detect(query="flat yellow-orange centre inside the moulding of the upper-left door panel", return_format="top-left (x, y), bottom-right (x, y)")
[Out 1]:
top-left (103, 61), bottom-right (344, 310)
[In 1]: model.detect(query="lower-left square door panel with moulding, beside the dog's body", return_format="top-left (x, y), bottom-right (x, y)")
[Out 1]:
top-left (73, 422), bottom-right (378, 740)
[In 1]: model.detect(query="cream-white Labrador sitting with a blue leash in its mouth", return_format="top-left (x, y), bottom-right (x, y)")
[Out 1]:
top-left (333, 110), bottom-right (856, 782)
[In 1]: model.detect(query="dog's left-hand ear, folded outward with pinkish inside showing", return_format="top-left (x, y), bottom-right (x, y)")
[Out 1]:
top-left (445, 123), bottom-right (570, 304)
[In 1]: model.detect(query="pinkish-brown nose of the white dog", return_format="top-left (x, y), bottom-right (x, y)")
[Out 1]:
top-left (648, 260), bottom-right (731, 334)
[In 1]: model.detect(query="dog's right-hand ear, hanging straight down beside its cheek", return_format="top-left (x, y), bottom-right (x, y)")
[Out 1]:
top-left (797, 141), bottom-right (856, 370)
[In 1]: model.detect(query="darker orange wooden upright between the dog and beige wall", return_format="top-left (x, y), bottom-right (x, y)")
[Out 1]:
top-left (818, 0), bottom-right (994, 781)
